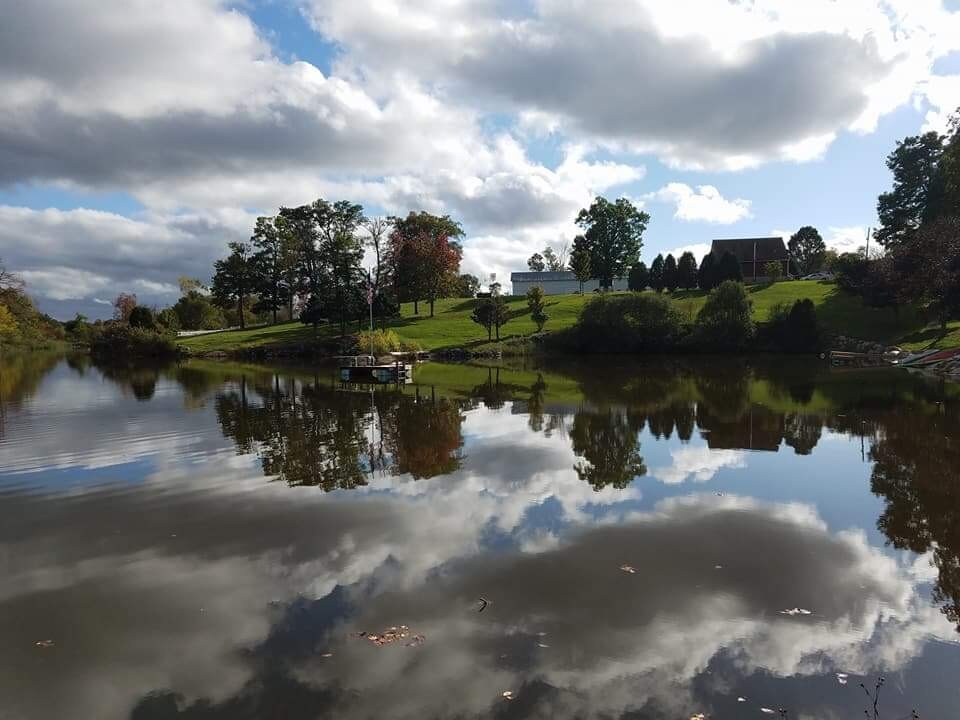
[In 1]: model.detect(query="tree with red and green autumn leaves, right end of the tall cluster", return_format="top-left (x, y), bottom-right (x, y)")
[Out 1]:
top-left (388, 212), bottom-right (463, 317)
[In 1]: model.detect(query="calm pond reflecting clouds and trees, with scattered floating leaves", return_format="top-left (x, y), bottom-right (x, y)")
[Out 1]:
top-left (0, 355), bottom-right (960, 720)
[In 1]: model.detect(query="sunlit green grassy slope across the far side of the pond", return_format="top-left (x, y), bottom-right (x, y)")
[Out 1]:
top-left (178, 280), bottom-right (960, 354)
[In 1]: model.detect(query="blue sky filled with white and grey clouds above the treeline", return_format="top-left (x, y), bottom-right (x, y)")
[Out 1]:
top-left (0, 0), bottom-right (960, 319)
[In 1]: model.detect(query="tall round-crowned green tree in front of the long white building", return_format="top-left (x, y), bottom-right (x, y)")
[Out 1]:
top-left (576, 197), bottom-right (650, 287)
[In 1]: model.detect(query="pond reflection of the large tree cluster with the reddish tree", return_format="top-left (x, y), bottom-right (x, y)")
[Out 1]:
top-left (214, 375), bottom-right (463, 491)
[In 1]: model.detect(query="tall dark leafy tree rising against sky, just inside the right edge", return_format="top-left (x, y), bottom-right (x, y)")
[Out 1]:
top-left (874, 131), bottom-right (946, 248)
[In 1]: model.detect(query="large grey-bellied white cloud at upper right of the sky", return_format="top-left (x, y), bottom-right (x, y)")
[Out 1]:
top-left (309, 0), bottom-right (958, 169)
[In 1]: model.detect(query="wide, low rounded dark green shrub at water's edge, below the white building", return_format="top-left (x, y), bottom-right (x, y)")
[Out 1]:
top-left (572, 294), bottom-right (684, 352)
